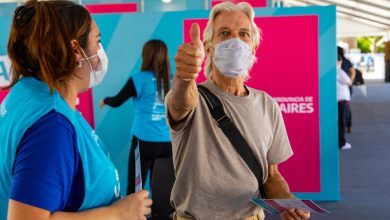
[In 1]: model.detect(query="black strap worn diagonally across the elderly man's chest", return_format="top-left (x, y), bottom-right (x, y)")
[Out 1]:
top-left (198, 85), bottom-right (265, 198)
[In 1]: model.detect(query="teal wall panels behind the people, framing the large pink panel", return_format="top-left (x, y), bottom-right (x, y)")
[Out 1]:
top-left (0, 6), bottom-right (340, 201)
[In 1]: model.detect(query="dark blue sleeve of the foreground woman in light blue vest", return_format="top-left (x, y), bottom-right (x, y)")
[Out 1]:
top-left (9, 111), bottom-right (78, 212)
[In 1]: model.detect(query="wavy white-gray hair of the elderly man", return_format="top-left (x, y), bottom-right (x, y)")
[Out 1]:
top-left (203, 2), bottom-right (261, 79)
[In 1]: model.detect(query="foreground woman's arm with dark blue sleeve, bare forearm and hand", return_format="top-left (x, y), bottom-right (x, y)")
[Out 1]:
top-left (7, 111), bottom-right (151, 220)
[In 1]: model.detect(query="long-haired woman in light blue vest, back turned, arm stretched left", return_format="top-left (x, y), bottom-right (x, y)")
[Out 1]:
top-left (100, 40), bottom-right (172, 194)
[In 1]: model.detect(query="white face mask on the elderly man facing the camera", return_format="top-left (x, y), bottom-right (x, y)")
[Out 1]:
top-left (213, 38), bottom-right (255, 78)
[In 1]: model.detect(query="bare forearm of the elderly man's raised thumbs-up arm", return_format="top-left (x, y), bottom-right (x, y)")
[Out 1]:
top-left (167, 76), bottom-right (199, 121)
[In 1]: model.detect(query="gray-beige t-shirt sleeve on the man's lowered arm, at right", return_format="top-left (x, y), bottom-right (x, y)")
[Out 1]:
top-left (267, 101), bottom-right (293, 165)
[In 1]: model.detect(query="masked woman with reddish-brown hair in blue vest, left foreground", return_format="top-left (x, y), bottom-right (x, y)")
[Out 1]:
top-left (0, 0), bottom-right (152, 220)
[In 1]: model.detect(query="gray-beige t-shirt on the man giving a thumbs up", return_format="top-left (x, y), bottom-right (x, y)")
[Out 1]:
top-left (167, 80), bottom-right (293, 220)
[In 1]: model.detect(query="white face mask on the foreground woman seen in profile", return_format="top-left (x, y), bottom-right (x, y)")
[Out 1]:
top-left (80, 43), bottom-right (108, 88)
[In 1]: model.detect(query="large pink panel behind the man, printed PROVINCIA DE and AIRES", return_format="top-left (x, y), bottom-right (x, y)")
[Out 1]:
top-left (184, 15), bottom-right (321, 192)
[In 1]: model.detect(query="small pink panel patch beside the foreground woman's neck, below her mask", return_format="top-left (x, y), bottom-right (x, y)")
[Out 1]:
top-left (76, 89), bottom-right (95, 128)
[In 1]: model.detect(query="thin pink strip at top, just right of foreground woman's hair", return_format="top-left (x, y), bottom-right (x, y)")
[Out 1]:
top-left (85, 3), bottom-right (138, 14)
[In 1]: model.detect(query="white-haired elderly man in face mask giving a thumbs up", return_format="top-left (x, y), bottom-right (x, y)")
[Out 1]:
top-left (166, 3), bottom-right (310, 220)
